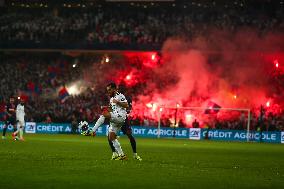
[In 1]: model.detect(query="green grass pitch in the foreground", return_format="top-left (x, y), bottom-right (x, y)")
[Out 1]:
top-left (0, 134), bottom-right (284, 189)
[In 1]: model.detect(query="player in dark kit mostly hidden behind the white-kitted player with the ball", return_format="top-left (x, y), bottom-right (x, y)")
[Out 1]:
top-left (108, 96), bottom-right (142, 161)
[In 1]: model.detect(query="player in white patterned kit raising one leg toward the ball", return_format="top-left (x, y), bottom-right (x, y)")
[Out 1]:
top-left (92, 83), bottom-right (129, 160)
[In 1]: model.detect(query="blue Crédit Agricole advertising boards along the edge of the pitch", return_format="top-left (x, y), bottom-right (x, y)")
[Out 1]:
top-left (0, 122), bottom-right (284, 143)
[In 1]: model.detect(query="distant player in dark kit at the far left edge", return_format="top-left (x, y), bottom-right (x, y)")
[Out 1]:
top-left (2, 97), bottom-right (17, 139)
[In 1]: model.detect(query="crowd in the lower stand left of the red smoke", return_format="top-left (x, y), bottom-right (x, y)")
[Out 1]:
top-left (0, 53), bottom-right (94, 122)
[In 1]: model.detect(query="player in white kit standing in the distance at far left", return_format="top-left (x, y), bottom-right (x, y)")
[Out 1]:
top-left (12, 99), bottom-right (25, 141)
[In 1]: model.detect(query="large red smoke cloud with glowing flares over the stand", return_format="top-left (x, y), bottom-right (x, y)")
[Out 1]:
top-left (81, 29), bottom-right (284, 127)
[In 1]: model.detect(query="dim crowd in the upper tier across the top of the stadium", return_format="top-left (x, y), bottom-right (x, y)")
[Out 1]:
top-left (0, 1), bottom-right (284, 45)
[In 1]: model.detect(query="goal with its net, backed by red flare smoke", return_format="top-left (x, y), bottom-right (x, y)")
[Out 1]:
top-left (155, 106), bottom-right (252, 141)
